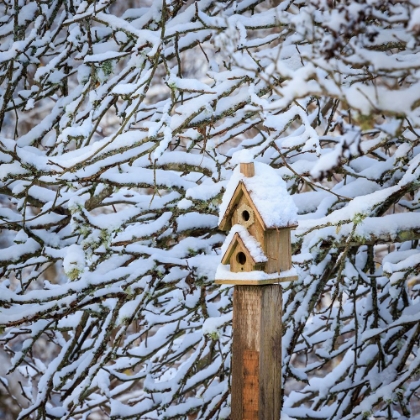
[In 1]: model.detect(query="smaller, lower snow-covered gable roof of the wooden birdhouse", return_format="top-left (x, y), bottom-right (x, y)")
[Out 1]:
top-left (222, 225), bottom-right (267, 264)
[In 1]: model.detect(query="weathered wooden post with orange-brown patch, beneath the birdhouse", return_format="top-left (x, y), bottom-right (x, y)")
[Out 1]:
top-left (231, 284), bottom-right (282, 420)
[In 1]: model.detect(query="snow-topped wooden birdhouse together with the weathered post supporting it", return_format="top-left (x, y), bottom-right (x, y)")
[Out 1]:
top-left (216, 158), bottom-right (297, 420)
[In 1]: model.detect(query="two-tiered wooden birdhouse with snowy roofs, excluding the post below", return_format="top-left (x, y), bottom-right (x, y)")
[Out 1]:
top-left (216, 162), bottom-right (297, 284)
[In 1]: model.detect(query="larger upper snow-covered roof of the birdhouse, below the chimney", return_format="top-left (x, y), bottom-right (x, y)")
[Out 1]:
top-left (219, 162), bottom-right (297, 229)
